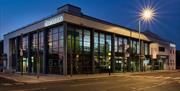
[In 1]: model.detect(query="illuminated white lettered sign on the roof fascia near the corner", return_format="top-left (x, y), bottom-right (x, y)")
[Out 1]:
top-left (44, 15), bottom-right (64, 27)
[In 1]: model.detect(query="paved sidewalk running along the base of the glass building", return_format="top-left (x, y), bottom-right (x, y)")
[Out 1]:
top-left (0, 71), bottom-right (177, 84)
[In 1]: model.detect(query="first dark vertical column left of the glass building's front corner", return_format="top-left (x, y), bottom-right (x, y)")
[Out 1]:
top-left (43, 30), bottom-right (49, 74)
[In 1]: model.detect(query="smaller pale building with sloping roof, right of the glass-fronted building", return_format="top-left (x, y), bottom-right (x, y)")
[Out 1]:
top-left (144, 31), bottom-right (176, 70)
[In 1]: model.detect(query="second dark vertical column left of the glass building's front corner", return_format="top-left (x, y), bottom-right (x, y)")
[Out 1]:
top-left (28, 33), bottom-right (32, 73)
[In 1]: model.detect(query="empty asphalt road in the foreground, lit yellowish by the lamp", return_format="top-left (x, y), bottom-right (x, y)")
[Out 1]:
top-left (0, 72), bottom-right (180, 91)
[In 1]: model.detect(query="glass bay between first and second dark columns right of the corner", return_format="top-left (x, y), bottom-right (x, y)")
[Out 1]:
top-left (94, 32), bottom-right (112, 72)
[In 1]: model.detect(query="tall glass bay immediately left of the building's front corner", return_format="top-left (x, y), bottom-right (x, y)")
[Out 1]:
top-left (48, 27), bottom-right (64, 74)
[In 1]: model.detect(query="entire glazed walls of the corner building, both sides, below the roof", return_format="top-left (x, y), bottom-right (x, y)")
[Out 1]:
top-left (11, 24), bottom-right (150, 74)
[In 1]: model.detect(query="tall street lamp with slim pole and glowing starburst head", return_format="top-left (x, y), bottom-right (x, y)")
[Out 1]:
top-left (139, 7), bottom-right (156, 70)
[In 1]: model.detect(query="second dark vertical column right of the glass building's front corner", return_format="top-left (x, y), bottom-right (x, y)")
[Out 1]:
top-left (111, 33), bottom-right (115, 72)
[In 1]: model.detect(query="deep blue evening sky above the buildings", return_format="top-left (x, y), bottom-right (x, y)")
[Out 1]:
top-left (0, 0), bottom-right (180, 49)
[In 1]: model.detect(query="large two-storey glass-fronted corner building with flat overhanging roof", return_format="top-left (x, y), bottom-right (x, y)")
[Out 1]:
top-left (4, 4), bottom-right (176, 75)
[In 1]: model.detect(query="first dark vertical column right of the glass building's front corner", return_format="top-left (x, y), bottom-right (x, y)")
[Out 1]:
top-left (91, 29), bottom-right (95, 73)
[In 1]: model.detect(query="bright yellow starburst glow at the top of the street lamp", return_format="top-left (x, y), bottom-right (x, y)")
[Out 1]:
top-left (140, 8), bottom-right (156, 21)
